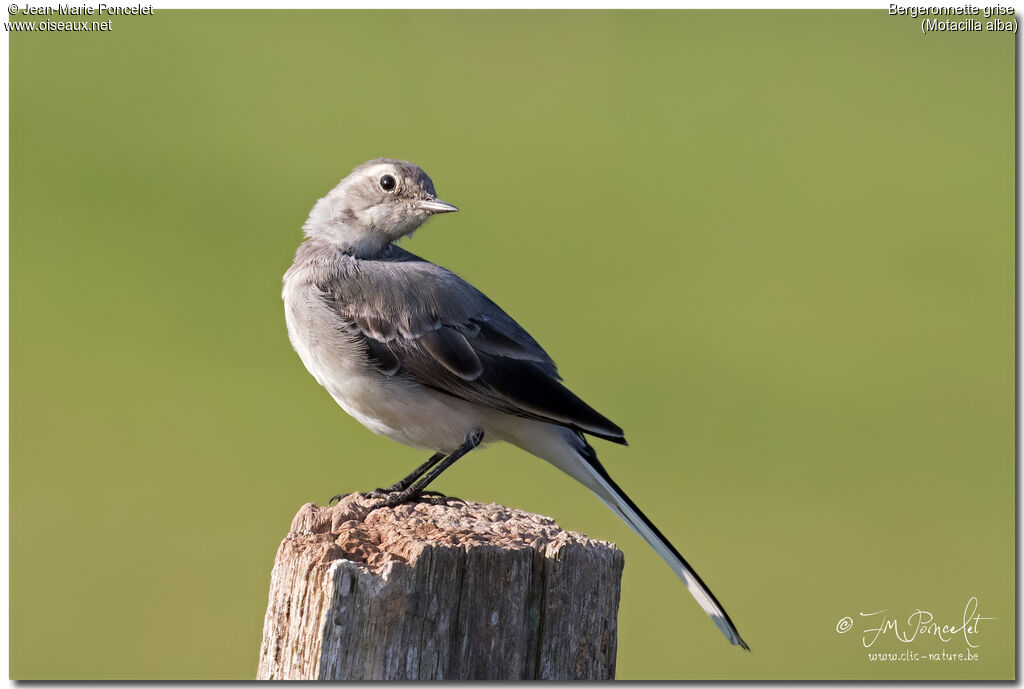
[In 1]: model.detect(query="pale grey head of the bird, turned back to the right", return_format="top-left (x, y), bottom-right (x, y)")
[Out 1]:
top-left (303, 158), bottom-right (459, 256)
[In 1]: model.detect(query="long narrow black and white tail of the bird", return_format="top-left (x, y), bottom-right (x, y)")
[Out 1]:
top-left (557, 436), bottom-right (751, 650)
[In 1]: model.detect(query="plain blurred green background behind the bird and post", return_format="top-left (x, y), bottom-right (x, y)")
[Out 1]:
top-left (10, 10), bottom-right (1015, 679)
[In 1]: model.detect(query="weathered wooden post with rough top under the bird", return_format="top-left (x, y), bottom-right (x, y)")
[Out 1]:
top-left (257, 493), bottom-right (623, 680)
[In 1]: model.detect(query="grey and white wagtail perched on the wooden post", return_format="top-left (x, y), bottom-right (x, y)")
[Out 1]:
top-left (282, 158), bottom-right (750, 650)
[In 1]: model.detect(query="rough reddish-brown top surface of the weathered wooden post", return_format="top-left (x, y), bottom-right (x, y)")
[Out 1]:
top-left (285, 492), bottom-right (621, 571)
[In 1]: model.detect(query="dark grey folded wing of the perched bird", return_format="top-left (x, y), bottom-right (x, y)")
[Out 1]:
top-left (317, 247), bottom-right (625, 443)
